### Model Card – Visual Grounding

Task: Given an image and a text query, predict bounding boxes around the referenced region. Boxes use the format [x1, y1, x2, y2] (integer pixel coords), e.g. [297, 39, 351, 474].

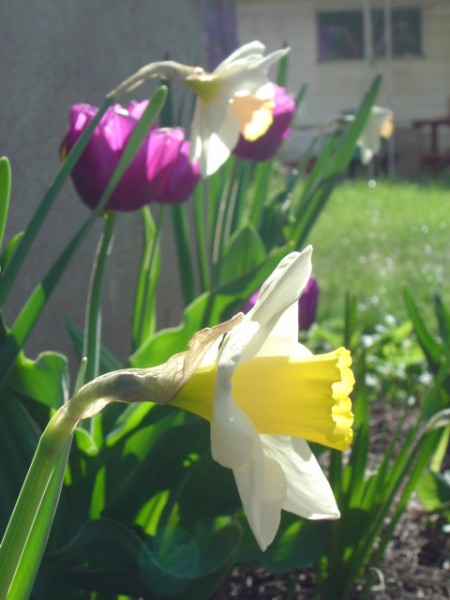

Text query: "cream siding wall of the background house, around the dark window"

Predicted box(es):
[237, 0, 450, 172]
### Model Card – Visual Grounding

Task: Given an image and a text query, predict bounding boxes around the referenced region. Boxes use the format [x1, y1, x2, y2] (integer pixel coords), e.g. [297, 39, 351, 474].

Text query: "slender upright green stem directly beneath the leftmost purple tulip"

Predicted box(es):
[83, 212, 116, 381]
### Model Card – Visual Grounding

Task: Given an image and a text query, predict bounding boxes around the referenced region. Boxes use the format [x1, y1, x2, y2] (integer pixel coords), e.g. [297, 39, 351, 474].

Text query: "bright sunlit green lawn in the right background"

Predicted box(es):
[309, 180, 450, 325]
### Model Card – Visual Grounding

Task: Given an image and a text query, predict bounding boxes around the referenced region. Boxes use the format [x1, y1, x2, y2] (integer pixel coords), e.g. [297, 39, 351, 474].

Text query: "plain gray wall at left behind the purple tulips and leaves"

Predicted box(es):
[0, 0, 202, 370]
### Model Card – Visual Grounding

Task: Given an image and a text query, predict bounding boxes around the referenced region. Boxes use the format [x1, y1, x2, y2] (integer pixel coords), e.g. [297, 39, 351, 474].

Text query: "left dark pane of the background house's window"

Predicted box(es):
[317, 11, 363, 61]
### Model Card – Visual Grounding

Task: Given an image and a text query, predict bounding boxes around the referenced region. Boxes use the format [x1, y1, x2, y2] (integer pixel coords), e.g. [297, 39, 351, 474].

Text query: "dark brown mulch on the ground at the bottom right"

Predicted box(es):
[212, 502, 450, 600]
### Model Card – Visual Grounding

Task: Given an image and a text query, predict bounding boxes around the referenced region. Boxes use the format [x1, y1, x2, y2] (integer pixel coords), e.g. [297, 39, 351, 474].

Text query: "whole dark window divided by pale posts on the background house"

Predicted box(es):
[317, 8, 422, 62]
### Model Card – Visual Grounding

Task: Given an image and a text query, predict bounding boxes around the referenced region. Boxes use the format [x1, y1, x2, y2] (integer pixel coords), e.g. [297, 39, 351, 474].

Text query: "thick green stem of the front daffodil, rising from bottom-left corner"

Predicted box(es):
[0, 405, 78, 600]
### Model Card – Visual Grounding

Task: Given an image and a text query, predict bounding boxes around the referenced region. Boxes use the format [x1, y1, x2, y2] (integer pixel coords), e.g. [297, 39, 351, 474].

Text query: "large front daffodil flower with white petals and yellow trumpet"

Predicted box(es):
[171, 247, 354, 550]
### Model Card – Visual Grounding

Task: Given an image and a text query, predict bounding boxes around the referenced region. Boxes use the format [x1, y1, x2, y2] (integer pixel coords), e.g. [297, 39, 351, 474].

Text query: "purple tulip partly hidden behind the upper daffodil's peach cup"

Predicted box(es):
[233, 83, 295, 162]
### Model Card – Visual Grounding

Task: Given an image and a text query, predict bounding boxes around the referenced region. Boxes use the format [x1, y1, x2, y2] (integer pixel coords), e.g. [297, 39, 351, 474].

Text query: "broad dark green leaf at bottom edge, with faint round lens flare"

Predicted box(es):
[48, 519, 241, 600]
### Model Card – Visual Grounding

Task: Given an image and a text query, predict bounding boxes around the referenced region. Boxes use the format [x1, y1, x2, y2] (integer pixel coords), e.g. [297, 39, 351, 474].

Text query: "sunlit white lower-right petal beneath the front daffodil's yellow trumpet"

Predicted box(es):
[260, 435, 340, 519]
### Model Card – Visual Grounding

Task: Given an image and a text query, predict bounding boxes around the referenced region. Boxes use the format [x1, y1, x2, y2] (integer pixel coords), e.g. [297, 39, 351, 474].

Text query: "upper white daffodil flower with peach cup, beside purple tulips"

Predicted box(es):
[184, 41, 289, 177]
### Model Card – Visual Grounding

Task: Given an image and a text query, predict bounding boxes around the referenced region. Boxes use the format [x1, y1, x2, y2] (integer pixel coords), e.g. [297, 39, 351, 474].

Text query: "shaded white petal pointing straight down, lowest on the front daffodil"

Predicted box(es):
[233, 440, 287, 550]
